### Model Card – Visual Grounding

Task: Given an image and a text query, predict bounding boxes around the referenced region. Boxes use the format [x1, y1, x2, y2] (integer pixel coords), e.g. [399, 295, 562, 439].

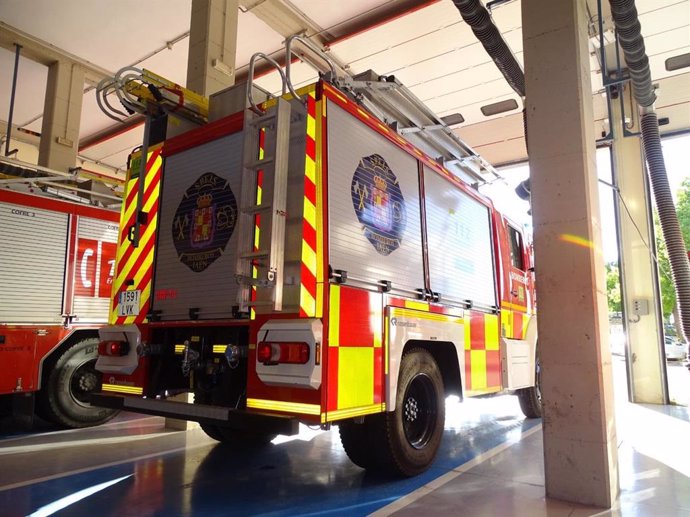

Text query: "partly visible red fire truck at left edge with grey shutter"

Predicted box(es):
[0, 188, 118, 427]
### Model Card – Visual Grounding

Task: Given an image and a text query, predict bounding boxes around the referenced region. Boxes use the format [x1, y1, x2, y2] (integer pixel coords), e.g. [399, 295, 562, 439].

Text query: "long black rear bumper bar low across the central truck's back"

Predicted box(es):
[91, 393, 299, 435]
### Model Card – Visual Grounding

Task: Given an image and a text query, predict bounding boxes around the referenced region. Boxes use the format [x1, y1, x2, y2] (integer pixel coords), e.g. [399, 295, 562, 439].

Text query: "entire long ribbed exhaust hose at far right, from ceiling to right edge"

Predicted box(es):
[609, 0, 690, 340]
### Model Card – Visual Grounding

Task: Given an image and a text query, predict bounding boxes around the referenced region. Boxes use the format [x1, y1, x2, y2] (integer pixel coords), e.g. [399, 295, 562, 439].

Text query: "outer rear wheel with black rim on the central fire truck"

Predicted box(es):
[372, 348, 446, 477]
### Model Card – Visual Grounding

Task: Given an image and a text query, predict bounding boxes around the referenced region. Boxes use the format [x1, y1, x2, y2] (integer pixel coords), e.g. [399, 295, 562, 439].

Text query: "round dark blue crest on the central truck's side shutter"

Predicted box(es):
[351, 154, 407, 256]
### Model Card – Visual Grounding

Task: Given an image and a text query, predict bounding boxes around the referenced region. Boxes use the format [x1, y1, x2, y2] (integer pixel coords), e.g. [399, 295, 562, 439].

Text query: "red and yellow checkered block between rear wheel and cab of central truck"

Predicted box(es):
[465, 311, 502, 396]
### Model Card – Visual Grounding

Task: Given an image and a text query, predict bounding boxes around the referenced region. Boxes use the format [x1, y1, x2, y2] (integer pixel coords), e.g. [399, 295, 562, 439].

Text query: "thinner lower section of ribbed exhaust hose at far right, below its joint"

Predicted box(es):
[641, 113, 690, 340]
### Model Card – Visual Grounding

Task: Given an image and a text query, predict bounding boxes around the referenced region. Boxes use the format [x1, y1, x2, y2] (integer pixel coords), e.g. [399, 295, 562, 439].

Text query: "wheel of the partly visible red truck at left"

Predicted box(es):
[37, 337, 118, 428]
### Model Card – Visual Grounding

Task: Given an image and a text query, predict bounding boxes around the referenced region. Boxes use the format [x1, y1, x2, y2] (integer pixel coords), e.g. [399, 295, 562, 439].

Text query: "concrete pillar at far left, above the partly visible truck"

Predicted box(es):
[38, 61, 84, 172]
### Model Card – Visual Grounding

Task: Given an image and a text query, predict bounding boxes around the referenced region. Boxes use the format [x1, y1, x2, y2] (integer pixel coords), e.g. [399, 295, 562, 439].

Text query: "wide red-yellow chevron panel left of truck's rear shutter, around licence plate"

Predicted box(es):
[109, 144, 163, 325]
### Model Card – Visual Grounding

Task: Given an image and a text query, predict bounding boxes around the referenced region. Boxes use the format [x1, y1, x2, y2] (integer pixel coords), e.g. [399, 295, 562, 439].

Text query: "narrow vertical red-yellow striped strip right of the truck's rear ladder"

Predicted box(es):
[299, 89, 320, 318]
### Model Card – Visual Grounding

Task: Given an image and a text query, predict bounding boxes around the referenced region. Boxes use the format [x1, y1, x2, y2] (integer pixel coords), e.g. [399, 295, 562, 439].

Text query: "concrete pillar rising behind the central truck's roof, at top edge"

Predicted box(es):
[187, 0, 239, 96]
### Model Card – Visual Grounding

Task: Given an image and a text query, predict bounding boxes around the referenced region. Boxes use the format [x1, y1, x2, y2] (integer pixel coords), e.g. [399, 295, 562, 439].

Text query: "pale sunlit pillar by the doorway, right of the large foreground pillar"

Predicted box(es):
[611, 84, 668, 404]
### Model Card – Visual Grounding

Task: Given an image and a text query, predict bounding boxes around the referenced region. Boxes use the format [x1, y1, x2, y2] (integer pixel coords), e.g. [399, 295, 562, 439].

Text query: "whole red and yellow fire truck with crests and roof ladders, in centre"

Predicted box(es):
[93, 48, 541, 475]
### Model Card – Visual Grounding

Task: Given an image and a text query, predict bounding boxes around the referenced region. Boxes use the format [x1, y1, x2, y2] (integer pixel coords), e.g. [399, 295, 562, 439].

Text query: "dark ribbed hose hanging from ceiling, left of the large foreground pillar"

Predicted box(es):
[453, 0, 525, 97]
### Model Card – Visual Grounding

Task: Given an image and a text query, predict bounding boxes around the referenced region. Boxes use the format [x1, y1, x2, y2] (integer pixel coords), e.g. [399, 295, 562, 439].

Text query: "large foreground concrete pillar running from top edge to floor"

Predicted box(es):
[522, 0, 618, 508]
